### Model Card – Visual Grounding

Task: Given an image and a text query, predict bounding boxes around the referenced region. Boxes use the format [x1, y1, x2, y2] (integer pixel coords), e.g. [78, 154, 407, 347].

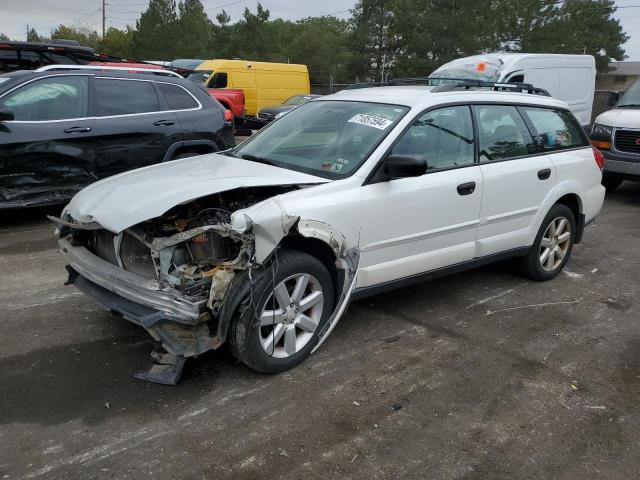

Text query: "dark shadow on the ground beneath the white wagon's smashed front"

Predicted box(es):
[0, 320, 250, 426]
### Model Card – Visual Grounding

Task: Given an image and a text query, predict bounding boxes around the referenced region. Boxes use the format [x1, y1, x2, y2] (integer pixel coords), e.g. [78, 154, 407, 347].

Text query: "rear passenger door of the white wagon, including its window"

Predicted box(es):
[474, 105, 557, 257]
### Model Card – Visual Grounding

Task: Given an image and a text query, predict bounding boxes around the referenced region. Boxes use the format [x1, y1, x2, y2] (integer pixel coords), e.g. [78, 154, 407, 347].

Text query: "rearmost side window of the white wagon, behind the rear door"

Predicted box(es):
[521, 107, 587, 152]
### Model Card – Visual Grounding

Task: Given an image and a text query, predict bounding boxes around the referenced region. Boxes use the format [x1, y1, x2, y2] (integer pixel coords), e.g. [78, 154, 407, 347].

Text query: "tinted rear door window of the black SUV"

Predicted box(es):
[96, 78, 160, 117]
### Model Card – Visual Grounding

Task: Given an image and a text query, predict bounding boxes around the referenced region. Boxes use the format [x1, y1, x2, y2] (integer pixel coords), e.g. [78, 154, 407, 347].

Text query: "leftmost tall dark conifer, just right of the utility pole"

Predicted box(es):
[133, 0, 181, 60]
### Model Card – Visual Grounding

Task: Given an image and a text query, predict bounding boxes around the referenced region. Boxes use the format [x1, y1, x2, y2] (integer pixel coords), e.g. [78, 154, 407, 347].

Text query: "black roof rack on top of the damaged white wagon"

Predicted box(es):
[346, 77, 551, 97]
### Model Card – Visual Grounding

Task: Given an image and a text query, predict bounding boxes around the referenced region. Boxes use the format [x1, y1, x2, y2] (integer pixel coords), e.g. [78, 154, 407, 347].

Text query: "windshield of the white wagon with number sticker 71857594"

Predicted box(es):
[229, 100, 409, 179]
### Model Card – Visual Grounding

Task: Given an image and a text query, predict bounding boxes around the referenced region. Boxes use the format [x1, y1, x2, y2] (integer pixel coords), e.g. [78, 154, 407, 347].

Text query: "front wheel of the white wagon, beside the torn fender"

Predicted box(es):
[230, 250, 334, 373]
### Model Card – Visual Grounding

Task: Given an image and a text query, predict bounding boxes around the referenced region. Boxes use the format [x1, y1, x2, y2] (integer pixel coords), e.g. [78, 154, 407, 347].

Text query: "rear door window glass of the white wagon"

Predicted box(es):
[475, 105, 538, 162]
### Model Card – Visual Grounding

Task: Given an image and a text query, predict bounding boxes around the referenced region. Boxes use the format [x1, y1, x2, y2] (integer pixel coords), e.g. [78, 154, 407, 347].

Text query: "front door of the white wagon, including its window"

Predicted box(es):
[357, 105, 483, 287]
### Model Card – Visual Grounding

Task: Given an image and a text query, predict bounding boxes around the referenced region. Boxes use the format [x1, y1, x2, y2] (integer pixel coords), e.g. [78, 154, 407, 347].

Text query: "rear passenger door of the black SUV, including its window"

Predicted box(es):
[94, 77, 182, 178]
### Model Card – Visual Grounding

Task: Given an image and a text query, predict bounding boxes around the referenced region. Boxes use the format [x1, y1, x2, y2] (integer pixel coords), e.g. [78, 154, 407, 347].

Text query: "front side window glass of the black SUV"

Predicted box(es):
[0, 75, 89, 121]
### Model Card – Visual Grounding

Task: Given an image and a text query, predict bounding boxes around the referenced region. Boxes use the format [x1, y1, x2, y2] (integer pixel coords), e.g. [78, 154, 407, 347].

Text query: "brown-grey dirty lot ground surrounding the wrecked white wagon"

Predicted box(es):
[0, 182, 640, 480]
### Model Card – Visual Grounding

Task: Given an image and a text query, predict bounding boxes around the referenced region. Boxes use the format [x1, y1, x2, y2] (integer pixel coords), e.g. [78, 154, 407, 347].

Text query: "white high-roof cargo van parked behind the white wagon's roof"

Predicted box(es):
[430, 53, 596, 126]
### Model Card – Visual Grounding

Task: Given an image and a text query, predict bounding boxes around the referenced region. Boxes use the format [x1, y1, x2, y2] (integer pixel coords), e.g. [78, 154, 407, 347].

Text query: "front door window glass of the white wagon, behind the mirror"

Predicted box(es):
[392, 106, 474, 171]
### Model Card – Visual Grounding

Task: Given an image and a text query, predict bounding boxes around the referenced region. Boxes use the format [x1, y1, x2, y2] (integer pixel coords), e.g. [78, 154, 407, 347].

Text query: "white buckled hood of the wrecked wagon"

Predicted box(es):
[68, 153, 330, 233]
